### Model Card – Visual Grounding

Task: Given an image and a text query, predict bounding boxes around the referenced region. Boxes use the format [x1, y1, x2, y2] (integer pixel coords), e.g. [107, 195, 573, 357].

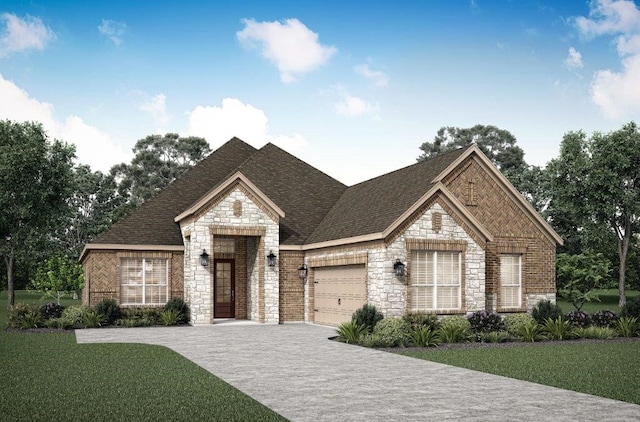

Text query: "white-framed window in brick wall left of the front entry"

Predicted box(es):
[120, 258, 169, 305]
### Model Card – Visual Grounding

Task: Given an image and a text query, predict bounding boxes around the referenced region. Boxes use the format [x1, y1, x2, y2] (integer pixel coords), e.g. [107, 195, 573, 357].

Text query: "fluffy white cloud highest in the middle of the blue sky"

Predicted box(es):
[236, 19, 338, 83]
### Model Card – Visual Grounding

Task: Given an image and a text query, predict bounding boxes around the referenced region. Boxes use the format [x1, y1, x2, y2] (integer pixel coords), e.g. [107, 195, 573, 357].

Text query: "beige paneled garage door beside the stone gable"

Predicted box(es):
[314, 265, 367, 326]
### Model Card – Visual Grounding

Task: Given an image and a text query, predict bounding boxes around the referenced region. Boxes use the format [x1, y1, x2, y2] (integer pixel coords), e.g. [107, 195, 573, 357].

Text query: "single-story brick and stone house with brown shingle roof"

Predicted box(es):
[81, 138, 562, 325]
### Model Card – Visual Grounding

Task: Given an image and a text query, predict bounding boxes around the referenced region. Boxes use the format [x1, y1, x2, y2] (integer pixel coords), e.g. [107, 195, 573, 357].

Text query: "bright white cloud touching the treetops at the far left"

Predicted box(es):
[0, 75, 132, 172]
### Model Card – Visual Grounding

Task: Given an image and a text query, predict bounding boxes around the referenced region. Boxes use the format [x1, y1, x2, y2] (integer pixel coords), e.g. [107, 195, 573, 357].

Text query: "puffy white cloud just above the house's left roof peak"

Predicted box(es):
[188, 98, 308, 153]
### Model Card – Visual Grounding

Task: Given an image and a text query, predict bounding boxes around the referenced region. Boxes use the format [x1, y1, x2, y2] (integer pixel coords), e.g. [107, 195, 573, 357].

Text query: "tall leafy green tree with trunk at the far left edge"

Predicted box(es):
[0, 120, 75, 307]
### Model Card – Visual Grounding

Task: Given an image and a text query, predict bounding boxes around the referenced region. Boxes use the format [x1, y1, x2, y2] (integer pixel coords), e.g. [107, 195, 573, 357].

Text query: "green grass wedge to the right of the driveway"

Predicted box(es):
[401, 341, 640, 404]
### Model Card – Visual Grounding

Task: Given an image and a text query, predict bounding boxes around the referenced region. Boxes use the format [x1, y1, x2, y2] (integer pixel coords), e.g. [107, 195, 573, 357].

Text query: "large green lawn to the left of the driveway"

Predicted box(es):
[0, 291, 285, 421]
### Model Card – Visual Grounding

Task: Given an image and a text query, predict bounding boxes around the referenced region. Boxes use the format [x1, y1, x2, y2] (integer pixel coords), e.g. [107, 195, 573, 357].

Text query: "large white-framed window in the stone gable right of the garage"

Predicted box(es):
[411, 251, 462, 311]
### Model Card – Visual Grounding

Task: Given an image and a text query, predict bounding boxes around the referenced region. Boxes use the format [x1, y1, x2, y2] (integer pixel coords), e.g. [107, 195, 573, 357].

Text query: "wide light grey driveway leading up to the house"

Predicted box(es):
[76, 323, 640, 422]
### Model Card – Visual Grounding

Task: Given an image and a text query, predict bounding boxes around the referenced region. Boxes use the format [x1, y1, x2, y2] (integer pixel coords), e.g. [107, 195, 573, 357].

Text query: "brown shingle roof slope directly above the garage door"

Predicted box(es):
[306, 148, 467, 244]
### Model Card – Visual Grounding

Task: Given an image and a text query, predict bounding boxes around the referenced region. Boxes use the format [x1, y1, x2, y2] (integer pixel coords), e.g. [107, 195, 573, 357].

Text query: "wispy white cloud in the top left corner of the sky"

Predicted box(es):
[0, 13, 56, 58]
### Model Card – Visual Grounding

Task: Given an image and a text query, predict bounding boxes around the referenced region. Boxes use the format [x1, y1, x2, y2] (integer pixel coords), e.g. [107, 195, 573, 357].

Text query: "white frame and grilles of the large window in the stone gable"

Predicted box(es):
[411, 250, 462, 311]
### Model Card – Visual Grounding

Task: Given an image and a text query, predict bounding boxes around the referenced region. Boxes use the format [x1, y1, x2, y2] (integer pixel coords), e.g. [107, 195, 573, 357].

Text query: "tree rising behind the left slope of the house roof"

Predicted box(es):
[110, 133, 211, 208]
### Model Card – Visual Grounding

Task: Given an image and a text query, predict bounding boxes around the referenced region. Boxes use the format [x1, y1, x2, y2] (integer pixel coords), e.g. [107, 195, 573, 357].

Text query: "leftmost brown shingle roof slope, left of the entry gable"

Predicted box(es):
[92, 138, 256, 246]
